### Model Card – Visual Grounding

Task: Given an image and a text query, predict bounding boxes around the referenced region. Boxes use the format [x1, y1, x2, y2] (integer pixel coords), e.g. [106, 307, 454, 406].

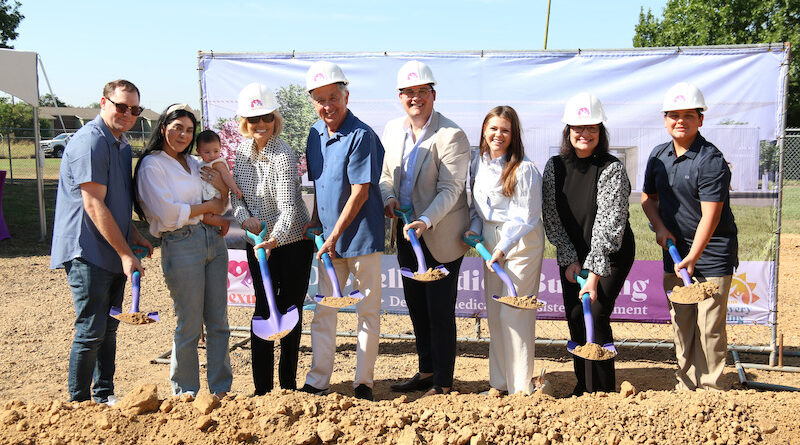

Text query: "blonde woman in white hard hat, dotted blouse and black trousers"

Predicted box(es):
[231, 83, 314, 395]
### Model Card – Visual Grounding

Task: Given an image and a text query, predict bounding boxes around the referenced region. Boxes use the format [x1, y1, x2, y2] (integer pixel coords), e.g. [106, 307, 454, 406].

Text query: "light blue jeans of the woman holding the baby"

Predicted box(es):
[161, 223, 233, 395]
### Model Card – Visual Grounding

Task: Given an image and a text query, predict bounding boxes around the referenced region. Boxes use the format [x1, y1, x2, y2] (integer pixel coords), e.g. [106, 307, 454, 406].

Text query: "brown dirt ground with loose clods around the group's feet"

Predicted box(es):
[0, 235, 800, 445]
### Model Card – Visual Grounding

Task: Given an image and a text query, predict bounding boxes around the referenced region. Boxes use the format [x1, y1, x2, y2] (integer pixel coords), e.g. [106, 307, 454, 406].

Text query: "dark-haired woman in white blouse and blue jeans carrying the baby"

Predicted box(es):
[134, 104, 233, 397]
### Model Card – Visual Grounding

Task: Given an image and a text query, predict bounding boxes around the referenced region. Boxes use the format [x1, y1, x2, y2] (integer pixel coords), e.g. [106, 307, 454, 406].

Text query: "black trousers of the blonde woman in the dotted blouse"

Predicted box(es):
[247, 240, 314, 395]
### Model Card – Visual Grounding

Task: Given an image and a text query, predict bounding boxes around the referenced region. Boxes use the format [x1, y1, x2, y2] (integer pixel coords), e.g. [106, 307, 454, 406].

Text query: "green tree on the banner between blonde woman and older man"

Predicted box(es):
[275, 84, 318, 155]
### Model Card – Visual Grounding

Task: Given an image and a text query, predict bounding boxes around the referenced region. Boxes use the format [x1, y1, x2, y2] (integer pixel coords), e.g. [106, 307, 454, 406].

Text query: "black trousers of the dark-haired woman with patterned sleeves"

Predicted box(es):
[560, 250, 633, 394]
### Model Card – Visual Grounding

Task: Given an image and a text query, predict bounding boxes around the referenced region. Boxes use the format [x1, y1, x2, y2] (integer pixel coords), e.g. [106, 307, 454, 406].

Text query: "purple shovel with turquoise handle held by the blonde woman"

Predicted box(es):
[245, 222, 300, 341]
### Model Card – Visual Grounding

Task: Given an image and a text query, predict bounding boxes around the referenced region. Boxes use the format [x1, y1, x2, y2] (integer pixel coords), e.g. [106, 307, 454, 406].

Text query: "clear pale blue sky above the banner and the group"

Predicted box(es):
[11, 0, 666, 111]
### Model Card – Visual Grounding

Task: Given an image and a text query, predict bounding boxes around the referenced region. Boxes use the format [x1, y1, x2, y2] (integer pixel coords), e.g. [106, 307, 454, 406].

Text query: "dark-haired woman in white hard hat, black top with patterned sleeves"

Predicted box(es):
[542, 93, 636, 395]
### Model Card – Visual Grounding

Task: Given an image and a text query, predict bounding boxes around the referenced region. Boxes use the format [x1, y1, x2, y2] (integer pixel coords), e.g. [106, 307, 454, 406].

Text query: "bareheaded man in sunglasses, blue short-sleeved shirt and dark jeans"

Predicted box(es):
[50, 80, 153, 404]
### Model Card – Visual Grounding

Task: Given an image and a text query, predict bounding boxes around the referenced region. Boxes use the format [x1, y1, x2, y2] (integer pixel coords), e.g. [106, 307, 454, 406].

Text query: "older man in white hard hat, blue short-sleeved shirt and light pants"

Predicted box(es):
[301, 62, 384, 400]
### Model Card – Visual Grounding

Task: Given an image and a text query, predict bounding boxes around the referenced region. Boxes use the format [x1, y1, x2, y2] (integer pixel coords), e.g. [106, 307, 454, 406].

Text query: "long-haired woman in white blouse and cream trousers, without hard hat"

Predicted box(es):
[466, 106, 544, 394]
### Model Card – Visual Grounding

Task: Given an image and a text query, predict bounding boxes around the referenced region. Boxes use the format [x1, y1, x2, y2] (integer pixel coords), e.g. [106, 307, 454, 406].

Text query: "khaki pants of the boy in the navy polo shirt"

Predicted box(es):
[664, 273, 732, 390]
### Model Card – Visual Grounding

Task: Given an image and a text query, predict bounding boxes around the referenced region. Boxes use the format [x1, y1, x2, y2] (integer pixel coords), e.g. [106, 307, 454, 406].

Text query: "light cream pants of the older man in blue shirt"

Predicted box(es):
[306, 252, 383, 389]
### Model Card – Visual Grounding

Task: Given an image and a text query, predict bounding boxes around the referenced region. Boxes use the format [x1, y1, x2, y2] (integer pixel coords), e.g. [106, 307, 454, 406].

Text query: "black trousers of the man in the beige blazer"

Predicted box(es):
[397, 224, 464, 388]
